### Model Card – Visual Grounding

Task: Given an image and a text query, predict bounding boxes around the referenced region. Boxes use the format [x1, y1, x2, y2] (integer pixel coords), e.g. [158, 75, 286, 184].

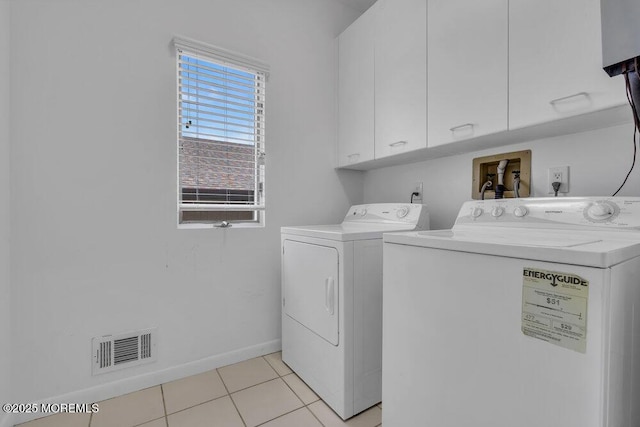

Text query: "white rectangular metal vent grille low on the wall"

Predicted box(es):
[92, 328, 157, 375]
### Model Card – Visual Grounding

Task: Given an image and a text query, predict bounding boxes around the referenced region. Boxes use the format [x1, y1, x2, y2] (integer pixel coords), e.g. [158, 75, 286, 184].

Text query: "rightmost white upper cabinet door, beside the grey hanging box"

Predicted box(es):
[509, 0, 626, 129]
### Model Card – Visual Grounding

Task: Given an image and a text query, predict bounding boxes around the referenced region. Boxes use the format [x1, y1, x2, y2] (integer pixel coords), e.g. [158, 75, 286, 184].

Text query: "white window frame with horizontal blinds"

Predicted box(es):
[173, 37, 269, 228]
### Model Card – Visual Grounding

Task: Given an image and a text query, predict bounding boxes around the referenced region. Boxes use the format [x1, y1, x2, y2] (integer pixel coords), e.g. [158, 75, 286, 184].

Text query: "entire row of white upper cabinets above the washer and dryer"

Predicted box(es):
[338, 0, 640, 169]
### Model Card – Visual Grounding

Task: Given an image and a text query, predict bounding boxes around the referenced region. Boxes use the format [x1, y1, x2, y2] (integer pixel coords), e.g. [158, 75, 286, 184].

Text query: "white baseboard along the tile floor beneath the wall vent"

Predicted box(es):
[13, 339, 282, 427]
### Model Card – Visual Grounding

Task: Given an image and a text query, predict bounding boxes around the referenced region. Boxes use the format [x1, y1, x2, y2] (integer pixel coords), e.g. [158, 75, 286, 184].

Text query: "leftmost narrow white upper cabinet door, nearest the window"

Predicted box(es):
[338, 5, 375, 166]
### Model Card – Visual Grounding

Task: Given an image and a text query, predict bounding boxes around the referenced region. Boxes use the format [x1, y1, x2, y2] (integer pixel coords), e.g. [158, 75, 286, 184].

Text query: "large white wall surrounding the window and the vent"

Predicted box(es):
[10, 0, 363, 402]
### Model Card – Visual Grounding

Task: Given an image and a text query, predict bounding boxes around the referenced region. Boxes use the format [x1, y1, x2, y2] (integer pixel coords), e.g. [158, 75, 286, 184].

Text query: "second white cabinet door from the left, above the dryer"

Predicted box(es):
[375, 0, 427, 159]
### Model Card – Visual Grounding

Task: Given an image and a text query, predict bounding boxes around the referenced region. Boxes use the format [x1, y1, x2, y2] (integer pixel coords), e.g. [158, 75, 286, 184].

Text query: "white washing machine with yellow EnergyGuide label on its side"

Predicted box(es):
[382, 197, 640, 427]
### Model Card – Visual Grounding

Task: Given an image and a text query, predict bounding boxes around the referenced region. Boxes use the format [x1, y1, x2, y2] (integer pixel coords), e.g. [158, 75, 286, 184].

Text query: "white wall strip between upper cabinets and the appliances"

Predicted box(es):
[364, 123, 640, 229]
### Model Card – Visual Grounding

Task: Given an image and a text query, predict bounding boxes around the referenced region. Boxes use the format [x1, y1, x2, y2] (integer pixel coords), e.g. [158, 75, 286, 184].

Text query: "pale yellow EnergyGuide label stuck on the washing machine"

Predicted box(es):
[522, 267, 589, 353]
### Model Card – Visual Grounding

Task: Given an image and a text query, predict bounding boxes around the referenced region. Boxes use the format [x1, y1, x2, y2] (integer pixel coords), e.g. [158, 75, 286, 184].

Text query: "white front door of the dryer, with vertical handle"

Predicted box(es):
[282, 240, 339, 345]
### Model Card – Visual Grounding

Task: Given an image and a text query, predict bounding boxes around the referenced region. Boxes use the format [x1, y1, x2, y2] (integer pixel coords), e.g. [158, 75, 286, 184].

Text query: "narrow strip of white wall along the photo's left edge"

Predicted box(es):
[0, 0, 11, 426]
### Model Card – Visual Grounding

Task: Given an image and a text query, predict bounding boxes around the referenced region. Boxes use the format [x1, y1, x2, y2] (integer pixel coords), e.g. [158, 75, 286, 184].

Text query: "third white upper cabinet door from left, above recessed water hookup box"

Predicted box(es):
[427, 0, 508, 147]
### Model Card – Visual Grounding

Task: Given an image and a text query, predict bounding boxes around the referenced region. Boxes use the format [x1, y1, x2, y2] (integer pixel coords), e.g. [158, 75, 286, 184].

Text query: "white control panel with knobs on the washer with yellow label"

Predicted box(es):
[456, 197, 640, 230]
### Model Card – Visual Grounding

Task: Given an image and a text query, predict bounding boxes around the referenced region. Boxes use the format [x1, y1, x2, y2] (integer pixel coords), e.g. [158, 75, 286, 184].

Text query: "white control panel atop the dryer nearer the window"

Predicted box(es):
[343, 203, 429, 229]
